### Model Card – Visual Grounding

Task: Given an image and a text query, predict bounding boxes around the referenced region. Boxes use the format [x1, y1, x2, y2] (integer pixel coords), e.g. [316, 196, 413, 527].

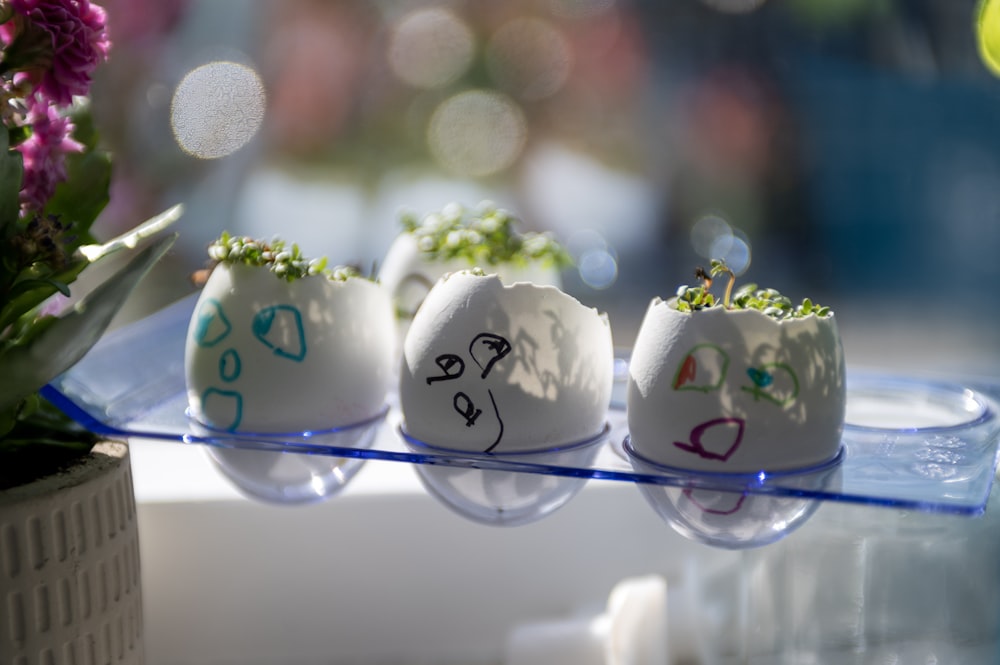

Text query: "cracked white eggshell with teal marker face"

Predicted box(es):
[184, 264, 395, 432]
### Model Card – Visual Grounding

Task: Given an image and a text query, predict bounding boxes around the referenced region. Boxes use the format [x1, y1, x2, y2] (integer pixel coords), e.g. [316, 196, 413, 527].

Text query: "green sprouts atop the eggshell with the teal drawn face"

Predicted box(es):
[208, 231, 361, 282]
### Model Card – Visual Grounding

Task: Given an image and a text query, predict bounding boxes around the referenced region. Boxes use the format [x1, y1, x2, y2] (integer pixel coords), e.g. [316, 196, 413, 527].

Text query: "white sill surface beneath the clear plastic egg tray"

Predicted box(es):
[133, 441, 737, 665]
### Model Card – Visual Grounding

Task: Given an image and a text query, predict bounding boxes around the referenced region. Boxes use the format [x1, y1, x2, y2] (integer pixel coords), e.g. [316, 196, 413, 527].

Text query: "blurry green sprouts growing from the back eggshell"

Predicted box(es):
[401, 201, 572, 268]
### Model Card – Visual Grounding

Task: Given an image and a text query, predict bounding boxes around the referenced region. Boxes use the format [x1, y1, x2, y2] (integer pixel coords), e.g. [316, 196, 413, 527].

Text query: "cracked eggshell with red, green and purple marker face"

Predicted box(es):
[626, 298, 846, 473]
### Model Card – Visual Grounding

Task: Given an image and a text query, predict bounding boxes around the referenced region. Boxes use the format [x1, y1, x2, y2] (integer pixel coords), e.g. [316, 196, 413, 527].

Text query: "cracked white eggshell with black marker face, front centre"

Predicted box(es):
[399, 272, 614, 453]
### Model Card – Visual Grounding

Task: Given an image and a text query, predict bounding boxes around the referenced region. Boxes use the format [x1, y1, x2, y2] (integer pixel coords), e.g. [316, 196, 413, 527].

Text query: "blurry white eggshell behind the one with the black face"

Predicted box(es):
[379, 233, 562, 342]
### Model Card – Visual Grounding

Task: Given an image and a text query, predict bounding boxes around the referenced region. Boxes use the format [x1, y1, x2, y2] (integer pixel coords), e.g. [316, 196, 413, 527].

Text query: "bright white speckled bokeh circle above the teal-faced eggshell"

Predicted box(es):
[170, 61, 267, 159]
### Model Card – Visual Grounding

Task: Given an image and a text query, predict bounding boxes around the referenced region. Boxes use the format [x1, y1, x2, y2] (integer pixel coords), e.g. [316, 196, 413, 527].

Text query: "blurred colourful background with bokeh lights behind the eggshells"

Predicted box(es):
[94, 0, 1000, 377]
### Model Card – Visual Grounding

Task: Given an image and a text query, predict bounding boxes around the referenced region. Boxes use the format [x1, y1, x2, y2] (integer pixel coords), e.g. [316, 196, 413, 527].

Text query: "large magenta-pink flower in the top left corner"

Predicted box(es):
[2, 0, 111, 106]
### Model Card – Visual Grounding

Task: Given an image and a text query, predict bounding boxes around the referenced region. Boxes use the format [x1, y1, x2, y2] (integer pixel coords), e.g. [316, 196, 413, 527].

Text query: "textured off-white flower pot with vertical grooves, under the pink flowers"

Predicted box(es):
[0, 442, 144, 665]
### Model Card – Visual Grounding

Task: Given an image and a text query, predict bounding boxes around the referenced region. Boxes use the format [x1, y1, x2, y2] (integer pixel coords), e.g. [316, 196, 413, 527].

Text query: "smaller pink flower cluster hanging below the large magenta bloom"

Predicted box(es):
[17, 95, 83, 210]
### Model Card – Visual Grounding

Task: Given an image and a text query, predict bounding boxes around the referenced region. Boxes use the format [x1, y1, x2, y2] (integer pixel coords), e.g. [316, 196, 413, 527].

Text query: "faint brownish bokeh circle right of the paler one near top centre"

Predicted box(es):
[486, 18, 572, 100]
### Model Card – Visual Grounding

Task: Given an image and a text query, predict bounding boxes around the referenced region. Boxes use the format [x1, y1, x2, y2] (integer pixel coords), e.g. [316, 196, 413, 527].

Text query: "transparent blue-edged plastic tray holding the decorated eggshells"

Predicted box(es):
[44, 296, 1000, 515]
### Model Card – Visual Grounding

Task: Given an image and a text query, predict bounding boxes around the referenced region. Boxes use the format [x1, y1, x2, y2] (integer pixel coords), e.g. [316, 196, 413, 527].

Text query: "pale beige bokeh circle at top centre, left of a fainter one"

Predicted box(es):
[388, 7, 475, 88]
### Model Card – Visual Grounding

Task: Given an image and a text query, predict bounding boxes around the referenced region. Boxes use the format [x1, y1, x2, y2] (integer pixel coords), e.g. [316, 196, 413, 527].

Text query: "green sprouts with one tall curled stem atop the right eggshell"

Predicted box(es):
[672, 259, 830, 319]
